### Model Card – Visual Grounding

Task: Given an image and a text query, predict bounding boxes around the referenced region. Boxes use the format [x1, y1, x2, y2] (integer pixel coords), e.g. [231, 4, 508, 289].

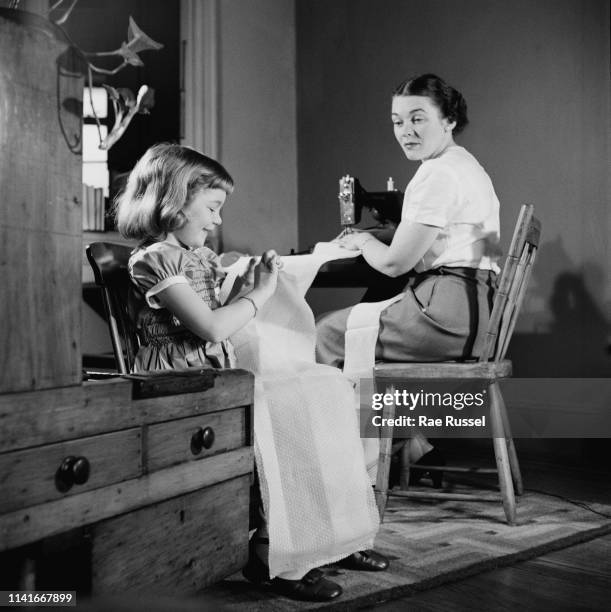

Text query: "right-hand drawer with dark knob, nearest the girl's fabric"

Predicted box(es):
[145, 406, 250, 472]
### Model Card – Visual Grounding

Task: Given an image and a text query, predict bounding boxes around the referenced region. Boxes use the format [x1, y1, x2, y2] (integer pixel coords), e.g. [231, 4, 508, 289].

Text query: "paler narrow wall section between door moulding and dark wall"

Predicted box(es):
[219, 0, 297, 253]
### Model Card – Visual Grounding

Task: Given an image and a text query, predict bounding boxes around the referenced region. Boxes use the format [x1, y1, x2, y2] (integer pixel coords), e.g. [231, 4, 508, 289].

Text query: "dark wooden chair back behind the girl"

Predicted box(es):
[85, 242, 140, 374]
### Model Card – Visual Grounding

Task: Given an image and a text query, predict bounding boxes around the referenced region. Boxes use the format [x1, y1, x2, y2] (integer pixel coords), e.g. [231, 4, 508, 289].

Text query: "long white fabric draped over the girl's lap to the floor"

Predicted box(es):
[221, 245, 379, 576]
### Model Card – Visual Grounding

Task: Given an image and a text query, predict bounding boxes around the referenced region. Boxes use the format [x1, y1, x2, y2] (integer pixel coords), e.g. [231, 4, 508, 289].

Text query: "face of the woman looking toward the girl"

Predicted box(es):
[392, 96, 456, 161]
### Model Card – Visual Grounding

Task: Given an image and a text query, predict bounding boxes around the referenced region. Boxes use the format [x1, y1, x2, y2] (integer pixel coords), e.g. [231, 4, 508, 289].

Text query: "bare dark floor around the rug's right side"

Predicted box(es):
[371, 441, 611, 612]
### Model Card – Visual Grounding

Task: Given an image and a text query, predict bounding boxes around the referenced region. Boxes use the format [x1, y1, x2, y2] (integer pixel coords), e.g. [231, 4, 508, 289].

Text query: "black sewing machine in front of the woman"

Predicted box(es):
[338, 174, 403, 234]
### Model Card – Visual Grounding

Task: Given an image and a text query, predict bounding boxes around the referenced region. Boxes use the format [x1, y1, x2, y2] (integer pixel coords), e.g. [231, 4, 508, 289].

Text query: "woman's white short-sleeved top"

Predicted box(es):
[401, 145, 500, 274]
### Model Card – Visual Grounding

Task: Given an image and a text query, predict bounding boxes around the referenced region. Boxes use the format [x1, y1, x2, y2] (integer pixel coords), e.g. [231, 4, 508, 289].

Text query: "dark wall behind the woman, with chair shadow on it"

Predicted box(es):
[296, 0, 611, 376]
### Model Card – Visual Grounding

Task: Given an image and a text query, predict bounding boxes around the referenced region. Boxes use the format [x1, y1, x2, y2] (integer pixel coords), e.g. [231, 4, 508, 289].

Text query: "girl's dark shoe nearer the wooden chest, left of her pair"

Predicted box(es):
[242, 537, 343, 601]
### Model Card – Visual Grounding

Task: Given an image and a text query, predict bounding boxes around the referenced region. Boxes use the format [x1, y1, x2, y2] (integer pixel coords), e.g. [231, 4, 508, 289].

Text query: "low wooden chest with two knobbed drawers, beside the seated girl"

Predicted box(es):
[0, 370, 253, 594]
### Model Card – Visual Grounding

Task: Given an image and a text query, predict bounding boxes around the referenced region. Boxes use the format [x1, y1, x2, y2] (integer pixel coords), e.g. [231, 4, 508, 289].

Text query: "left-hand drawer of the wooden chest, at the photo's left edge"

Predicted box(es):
[0, 428, 142, 513]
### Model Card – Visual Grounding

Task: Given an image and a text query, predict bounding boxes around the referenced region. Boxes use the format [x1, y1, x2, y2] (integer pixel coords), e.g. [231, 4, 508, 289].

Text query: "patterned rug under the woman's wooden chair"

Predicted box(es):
[204, 485, 611, 612]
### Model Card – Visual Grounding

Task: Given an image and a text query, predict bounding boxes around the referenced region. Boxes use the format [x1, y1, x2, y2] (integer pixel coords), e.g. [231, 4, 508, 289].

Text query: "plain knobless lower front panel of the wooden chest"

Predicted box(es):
[91, 475, 250, 597]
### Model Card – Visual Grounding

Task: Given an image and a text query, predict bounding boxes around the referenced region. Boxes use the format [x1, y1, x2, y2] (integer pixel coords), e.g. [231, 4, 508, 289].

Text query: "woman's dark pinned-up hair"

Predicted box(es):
[392, 73, 469, 134]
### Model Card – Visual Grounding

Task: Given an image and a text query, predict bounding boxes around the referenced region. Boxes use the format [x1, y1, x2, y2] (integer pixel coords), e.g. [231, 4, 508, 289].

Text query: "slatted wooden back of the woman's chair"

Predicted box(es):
[479, 204, 541, 363]
